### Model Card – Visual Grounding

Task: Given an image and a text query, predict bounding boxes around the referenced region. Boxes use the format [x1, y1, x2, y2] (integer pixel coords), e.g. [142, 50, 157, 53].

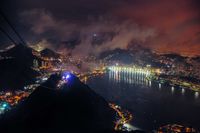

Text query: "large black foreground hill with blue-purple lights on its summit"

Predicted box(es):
[0, 75, 145, 133]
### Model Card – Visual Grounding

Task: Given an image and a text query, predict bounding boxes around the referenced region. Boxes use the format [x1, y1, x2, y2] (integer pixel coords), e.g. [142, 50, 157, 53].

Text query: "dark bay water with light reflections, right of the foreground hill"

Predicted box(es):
[87, 71, 200, 130]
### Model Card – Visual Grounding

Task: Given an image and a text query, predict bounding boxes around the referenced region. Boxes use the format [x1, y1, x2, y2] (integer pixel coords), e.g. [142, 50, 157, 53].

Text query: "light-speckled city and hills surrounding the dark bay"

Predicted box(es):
[0, 45, 200, 133]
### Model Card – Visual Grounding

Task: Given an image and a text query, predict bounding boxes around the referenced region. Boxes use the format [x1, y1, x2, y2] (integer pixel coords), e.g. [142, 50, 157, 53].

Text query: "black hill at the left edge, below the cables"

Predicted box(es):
[0, 44, 39, 90]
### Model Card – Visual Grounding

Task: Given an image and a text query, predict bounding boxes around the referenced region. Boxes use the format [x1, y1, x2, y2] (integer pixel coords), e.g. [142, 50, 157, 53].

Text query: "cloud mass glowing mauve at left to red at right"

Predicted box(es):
[17, 0, 200, 56]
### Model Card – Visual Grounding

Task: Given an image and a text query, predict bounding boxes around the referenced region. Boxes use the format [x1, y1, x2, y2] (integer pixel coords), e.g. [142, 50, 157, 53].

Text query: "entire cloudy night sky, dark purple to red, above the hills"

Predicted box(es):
[0, 0, 200, 56]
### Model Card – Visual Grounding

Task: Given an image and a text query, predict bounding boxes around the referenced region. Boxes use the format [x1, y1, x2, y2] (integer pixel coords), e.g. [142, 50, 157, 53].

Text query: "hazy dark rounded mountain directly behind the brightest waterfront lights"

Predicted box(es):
[99, 45, 161, 66]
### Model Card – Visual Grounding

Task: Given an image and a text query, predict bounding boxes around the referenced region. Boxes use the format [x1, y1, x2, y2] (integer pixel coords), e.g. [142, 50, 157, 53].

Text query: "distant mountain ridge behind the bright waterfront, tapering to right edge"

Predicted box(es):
[98, 45, 200, 68]
